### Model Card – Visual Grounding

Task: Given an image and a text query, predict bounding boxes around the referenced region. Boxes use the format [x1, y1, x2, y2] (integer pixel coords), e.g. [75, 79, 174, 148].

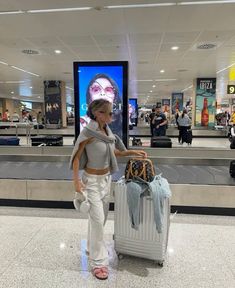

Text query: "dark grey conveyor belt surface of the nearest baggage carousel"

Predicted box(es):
[0, 161, 235, 186]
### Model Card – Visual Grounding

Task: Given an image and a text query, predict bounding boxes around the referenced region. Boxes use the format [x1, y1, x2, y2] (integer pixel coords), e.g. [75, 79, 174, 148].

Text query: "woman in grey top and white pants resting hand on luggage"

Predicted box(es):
[70, 99, 147, 280]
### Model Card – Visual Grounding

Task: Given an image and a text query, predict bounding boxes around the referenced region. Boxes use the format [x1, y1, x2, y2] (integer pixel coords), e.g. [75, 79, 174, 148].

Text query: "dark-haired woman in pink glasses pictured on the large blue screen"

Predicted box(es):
[80, 73, 122, 138]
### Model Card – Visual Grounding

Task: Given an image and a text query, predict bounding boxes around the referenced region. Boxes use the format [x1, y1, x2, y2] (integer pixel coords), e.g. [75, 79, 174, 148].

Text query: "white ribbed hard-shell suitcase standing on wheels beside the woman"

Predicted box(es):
[114, 180, 170, 266]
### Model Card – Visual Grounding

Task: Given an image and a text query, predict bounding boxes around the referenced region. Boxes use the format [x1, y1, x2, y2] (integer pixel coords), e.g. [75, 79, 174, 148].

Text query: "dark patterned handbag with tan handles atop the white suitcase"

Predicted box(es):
[125, 158, 155, 182]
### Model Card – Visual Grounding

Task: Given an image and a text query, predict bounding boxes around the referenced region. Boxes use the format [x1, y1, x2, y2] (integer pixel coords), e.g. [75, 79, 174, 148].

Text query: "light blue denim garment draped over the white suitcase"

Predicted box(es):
[126, 175, 171, 233]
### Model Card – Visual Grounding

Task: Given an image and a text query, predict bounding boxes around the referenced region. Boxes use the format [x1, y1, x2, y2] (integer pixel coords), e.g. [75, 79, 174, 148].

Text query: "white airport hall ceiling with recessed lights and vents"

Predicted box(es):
[0, 0, 235, 104]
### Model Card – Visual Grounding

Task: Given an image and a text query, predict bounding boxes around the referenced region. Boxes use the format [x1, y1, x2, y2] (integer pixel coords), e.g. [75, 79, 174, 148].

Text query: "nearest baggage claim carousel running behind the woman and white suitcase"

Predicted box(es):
[0, 146, 235, 215]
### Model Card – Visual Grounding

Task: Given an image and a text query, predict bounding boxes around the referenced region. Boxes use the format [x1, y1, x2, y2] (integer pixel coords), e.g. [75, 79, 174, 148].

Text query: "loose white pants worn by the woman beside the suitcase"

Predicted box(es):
[82, 172, 111, 268]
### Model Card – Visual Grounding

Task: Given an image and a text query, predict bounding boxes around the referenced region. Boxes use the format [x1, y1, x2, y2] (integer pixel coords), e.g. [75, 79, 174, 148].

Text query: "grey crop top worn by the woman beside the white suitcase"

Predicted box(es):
[85, 138, 115, 169]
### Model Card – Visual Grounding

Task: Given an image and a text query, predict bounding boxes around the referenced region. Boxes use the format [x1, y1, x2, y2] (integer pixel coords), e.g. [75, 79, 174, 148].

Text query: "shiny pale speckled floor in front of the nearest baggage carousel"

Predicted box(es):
[0, 207, 235, 288]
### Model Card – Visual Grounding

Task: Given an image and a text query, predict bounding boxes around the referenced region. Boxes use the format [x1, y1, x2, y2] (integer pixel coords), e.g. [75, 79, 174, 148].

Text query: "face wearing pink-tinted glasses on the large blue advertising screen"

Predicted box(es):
[89, 78, 115, 103]
